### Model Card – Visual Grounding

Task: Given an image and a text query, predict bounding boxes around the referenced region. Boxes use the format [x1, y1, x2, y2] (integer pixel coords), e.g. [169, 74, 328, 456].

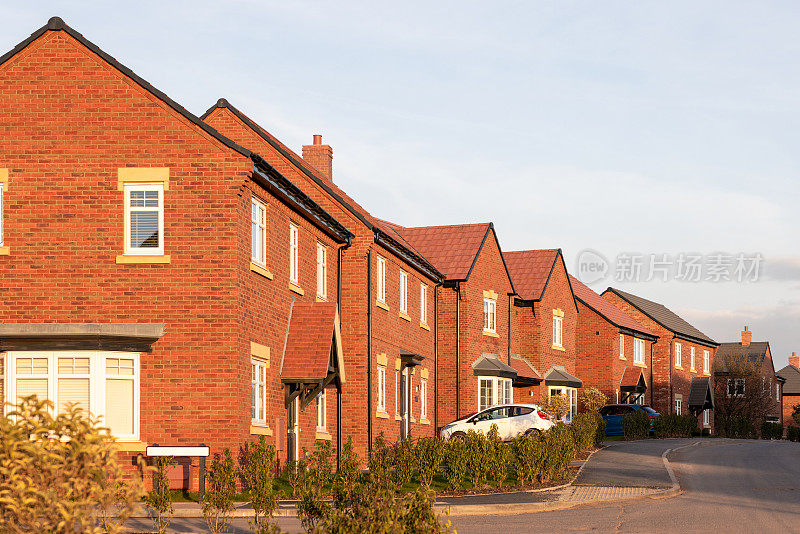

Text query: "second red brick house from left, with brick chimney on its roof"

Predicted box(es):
[198, 99, 442, 457]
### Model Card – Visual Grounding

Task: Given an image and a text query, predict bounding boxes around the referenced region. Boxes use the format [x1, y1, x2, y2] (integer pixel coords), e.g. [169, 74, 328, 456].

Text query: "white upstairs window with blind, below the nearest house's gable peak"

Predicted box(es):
[125, 184, 164, 255]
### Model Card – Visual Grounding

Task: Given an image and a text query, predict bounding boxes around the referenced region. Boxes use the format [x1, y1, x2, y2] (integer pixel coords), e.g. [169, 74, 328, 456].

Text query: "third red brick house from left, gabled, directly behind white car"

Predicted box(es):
[384, 223, 517, 424]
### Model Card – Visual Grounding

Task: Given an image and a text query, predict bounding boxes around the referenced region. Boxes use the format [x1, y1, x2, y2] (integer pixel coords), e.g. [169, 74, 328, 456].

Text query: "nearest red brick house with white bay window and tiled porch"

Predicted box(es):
[0, 18, 353, 486]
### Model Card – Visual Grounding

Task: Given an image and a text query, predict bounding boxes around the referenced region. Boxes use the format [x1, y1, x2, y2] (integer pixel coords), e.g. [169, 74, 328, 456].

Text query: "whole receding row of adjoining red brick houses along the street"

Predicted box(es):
[0, 18, 780, 490]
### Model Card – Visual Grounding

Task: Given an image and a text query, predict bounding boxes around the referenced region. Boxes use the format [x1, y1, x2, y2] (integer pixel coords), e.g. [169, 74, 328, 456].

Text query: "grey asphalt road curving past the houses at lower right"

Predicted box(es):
[129, 439, 800, 534]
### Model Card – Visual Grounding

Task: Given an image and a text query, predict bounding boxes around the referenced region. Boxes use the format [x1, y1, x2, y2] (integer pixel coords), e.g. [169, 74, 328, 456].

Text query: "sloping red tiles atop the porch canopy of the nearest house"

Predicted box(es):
[281, 302, 336, 381]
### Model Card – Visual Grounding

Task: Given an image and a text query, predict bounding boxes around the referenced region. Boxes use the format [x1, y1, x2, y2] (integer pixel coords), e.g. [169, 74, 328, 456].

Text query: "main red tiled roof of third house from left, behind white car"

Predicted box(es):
[383, 221, 491, 280]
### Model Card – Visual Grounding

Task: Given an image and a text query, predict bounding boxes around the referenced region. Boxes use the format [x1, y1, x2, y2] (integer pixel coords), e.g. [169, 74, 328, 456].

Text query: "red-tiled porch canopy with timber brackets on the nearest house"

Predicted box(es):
[280, 302, 345, 410]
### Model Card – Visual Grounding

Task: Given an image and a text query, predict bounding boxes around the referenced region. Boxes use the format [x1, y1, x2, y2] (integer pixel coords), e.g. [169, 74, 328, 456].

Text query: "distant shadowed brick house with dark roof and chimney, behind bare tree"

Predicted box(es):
[714, 326, 785, 428]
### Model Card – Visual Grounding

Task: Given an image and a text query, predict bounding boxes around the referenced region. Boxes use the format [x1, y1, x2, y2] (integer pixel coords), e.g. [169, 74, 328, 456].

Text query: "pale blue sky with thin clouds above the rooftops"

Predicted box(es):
[6, 0, 800, 369]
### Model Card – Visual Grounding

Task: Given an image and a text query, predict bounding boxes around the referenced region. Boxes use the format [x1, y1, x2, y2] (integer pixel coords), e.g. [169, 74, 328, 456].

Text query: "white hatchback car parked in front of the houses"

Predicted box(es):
[440, 404, 555, 441]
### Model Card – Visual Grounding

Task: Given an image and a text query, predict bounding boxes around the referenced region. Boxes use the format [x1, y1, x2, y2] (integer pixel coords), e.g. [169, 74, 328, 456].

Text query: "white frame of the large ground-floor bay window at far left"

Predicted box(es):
[4, 351, 141, 442]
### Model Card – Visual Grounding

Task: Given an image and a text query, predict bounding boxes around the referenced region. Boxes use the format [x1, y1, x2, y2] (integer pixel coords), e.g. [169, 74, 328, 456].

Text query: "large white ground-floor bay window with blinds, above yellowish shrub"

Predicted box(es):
[6, 351, 139, 441]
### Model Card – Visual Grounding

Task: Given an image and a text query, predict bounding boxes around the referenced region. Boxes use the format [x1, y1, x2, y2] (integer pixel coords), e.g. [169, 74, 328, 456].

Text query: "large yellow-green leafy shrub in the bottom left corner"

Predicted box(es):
[0, 396, 150, 533]
